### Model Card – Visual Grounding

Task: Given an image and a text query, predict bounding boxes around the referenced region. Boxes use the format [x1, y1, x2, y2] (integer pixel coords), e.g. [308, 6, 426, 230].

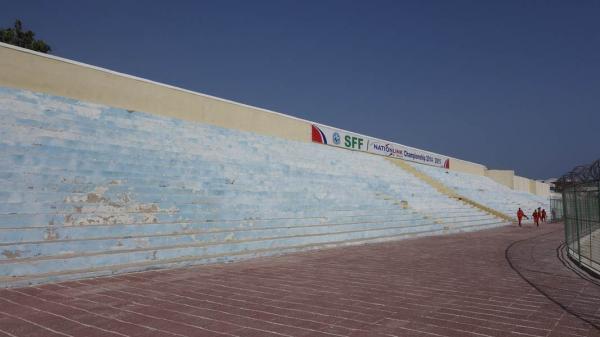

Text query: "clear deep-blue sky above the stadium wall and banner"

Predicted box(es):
[0, 0, 600, 178]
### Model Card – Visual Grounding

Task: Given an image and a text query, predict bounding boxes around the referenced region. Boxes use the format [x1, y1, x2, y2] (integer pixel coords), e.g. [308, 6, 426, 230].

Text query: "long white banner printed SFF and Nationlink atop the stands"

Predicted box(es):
[311, 124, 450, 168]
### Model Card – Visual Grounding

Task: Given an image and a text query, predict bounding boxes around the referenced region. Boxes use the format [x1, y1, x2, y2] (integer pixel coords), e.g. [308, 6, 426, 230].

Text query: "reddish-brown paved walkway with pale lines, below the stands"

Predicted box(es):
[0, 225, 600, 337]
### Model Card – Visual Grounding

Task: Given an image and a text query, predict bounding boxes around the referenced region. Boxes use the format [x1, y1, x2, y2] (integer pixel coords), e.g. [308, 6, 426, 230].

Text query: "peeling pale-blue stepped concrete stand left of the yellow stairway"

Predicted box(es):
[0, 87, 506, 287]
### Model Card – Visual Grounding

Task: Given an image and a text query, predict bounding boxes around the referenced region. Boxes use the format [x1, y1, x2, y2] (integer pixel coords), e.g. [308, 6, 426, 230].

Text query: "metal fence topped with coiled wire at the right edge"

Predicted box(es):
[558, 161, 600, 274]
